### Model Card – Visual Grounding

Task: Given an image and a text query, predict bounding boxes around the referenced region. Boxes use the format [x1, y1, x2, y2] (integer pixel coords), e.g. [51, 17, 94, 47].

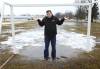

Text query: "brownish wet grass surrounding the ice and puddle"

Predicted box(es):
[0, 21, 100, 69]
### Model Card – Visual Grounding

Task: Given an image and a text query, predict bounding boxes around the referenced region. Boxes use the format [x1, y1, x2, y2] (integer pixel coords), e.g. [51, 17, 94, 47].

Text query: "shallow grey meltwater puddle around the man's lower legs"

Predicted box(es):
[20, 46, 83, 59]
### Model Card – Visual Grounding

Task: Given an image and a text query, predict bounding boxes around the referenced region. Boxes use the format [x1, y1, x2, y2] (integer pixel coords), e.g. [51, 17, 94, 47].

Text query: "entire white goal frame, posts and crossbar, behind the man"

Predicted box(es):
[0, 1, 99, 44]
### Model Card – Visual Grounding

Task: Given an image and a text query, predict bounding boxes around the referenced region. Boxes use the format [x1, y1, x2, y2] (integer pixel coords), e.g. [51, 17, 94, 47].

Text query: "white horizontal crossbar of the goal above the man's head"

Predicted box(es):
[4, 1, 100, 7]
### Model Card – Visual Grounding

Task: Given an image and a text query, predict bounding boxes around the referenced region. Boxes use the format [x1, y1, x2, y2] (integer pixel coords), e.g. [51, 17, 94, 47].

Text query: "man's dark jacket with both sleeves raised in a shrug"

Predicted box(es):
[38, 16, 64, 36]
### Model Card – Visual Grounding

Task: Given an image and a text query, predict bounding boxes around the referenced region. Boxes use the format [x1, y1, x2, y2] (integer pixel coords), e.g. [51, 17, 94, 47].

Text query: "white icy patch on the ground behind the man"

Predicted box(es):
[2, 28, 96, 53]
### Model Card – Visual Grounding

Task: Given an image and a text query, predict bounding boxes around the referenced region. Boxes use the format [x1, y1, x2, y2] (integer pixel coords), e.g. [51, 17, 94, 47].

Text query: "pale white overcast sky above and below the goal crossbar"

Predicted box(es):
[0, 0, 100, 15]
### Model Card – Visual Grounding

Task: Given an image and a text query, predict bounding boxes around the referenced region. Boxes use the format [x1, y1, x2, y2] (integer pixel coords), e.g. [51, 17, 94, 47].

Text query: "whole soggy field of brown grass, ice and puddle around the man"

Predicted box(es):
[0, 21, 100, 69]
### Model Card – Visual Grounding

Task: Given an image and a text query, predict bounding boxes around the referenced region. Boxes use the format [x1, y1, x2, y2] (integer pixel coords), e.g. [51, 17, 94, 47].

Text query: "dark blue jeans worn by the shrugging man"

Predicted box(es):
[44, 35, 56, 59]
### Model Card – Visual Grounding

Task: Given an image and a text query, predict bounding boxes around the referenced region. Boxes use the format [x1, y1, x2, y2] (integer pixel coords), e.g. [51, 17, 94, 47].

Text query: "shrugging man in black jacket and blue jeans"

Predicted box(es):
[37, 10, 65, 60]
